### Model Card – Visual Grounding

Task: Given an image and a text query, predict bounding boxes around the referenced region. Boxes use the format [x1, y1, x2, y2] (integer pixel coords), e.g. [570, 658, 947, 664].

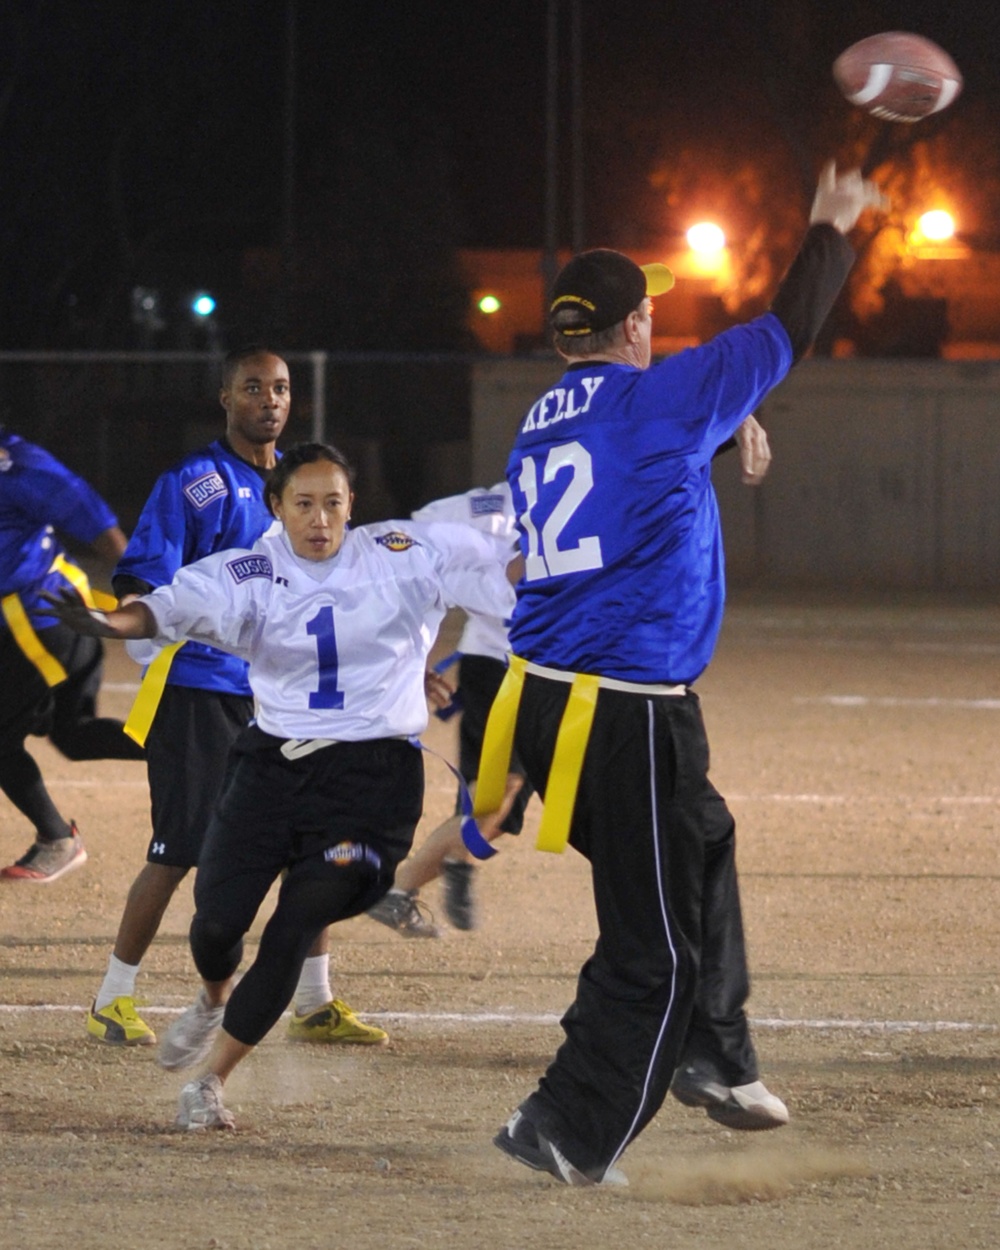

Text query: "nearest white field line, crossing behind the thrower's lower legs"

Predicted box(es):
[0, 1003, 1000, 1034]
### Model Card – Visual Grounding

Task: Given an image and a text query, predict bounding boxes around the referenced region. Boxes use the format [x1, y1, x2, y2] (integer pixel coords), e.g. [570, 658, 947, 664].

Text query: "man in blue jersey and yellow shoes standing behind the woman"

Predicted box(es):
[86, 344, 386, 1045]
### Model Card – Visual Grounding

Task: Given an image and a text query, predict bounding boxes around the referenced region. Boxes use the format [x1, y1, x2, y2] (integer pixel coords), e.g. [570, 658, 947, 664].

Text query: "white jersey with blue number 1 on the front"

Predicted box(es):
[143, 521, 514, 741]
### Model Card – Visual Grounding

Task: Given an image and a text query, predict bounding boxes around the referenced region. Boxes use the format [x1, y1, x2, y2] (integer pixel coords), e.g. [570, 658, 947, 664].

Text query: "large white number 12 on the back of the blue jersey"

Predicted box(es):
[518, 443, 604, 581]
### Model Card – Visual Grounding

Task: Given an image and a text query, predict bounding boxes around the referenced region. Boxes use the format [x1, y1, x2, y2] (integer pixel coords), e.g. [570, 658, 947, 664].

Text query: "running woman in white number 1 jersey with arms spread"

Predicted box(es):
[45, 444, 514, 1129]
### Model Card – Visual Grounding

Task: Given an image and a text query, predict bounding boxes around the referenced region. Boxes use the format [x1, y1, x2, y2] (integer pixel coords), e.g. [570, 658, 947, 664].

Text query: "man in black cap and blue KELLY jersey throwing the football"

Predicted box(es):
[487, 164, 881, 1185]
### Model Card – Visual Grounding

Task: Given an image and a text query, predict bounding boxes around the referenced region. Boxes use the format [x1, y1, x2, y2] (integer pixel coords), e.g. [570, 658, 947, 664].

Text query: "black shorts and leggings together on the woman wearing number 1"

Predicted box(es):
[191, 726, 424, 1046]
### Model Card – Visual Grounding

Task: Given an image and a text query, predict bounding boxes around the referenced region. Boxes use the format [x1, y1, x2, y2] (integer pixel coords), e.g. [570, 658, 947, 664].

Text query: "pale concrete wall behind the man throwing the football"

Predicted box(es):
[471, 358, 1000, 590]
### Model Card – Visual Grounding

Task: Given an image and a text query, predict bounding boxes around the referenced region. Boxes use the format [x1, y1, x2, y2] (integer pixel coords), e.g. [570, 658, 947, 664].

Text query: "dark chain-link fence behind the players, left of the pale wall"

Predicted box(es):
[0, 351, 475, 531]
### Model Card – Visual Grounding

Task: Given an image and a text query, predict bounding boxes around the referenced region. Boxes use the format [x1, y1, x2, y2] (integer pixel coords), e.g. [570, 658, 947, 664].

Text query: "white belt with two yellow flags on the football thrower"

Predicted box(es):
[463, 655, 688, 859]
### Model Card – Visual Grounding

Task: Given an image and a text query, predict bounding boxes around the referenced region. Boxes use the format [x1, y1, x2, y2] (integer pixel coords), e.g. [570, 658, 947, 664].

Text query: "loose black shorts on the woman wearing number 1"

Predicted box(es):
[195, 726, 424, 933]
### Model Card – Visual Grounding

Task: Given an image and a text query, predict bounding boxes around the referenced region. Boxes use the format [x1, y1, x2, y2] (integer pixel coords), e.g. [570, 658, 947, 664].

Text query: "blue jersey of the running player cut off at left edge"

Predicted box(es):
[0, 429, 118, 629]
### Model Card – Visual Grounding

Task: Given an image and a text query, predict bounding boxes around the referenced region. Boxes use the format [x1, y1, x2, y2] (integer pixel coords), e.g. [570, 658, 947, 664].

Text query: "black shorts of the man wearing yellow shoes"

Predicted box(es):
[146, 685, 254, 868]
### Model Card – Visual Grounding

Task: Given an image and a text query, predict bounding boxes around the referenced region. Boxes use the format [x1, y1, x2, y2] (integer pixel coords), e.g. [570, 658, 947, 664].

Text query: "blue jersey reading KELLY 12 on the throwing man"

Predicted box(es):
[508, 314, 791, 684]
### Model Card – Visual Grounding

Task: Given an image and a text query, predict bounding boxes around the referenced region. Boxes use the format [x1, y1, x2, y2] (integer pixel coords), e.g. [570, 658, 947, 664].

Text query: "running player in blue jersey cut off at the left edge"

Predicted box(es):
[0, 426, 143, 885]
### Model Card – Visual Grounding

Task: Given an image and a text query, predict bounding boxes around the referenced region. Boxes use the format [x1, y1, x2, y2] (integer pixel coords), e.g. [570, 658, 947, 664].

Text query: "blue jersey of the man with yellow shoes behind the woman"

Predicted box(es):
[115, 441, 274, 698]
